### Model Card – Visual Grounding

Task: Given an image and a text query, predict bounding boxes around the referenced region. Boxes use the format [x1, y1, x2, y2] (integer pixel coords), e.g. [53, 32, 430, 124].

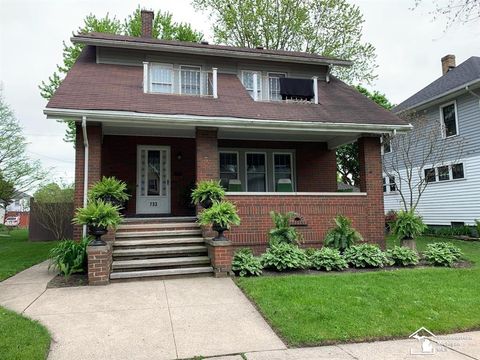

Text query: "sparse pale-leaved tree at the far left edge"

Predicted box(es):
[0, 92, 47, 206]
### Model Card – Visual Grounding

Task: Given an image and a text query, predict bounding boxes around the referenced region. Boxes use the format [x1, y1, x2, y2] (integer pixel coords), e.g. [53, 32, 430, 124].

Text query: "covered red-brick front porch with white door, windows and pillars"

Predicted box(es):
[75, 124, 384, 252]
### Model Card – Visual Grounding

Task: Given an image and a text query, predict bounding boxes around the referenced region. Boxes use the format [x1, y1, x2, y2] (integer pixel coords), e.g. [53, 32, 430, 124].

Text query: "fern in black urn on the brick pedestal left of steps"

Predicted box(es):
[73, 200, 122, 246]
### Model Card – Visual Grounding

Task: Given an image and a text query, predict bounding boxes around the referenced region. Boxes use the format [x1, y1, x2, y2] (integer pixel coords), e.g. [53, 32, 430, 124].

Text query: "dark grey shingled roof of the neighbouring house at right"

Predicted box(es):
[392, 56, 480, 113]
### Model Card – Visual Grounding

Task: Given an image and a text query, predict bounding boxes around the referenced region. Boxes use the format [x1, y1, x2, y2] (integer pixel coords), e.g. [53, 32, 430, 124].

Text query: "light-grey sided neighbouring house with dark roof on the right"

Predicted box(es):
[384, 55, 480, 225]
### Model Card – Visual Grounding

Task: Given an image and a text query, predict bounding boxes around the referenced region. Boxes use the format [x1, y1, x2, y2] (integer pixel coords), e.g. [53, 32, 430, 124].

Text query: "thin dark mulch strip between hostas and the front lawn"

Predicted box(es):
[261, 261, 472, 276]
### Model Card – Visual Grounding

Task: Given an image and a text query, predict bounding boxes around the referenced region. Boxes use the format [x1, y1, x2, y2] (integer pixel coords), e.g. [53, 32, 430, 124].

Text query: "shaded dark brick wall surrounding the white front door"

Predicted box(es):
[102, 135, 195, 215]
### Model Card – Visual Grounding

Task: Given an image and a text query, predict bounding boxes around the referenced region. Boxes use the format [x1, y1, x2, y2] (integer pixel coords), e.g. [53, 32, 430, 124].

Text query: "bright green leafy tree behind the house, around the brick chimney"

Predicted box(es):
[39, 7, 203, 143]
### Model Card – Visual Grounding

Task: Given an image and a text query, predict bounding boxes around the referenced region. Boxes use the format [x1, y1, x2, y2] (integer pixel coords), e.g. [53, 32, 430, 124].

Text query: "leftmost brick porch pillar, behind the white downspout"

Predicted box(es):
[73, 124, 102, 240]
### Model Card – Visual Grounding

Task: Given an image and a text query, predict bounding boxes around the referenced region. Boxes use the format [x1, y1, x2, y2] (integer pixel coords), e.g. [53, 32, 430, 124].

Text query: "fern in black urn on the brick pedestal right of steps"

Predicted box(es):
[198, 201, 240, 241]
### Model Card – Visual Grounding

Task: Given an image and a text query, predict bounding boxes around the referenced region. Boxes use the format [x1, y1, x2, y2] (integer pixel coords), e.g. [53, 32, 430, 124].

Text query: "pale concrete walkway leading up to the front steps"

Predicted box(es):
[0, 263, 285, 360]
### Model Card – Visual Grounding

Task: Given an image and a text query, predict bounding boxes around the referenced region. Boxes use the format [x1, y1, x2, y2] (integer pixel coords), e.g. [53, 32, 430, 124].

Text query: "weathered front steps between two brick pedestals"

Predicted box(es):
[110, 217, 213, 280]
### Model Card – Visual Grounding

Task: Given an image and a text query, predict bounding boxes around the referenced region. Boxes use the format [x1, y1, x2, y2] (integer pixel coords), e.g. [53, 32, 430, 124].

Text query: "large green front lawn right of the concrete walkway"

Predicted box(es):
[237, 237, 480, 346]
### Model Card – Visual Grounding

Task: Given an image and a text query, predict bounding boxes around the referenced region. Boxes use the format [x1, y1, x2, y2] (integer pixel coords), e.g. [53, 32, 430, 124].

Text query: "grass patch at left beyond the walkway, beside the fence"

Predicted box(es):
[0, 230, 57, 281]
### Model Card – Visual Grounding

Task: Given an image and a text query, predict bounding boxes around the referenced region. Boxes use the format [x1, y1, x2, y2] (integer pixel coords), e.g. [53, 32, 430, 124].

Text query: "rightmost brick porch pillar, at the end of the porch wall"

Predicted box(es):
[358, 137, 385, 248]
